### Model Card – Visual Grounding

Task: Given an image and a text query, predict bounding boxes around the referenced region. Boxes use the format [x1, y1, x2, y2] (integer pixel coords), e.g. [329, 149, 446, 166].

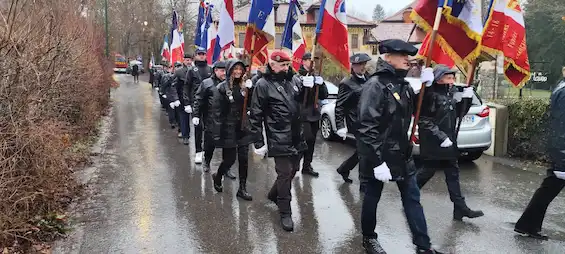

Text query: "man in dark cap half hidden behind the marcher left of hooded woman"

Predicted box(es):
[194, 47, 212, 164]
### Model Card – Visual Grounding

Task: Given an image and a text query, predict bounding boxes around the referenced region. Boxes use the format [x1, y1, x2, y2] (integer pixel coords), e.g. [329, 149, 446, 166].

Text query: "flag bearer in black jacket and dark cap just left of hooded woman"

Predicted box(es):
[192, 61, 225, 172]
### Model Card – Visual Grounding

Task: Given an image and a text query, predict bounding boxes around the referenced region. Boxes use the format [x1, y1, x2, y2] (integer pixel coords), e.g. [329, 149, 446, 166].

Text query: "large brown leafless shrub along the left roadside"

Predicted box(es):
[0, 0, 113, 249]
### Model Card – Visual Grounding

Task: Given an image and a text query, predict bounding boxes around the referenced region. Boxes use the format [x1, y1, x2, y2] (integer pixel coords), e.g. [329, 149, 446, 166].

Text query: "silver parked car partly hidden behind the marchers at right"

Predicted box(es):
[320, 78, 492, 161]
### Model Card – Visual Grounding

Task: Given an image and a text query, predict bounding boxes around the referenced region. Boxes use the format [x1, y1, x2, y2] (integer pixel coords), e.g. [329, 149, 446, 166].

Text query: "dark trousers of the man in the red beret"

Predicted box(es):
[268, 155, 300, 216]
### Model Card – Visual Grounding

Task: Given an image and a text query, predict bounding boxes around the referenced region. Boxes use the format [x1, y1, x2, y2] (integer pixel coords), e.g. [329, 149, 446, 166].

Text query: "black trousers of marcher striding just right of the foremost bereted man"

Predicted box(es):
[417, 160, 467, 208]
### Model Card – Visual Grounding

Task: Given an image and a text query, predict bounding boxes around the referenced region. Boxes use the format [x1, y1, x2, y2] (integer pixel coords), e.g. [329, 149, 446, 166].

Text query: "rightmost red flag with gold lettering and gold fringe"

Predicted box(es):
[482, 0, 531, 87]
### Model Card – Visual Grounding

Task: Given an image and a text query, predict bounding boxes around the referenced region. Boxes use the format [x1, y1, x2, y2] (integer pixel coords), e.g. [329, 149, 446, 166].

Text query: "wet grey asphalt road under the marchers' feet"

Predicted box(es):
[55, 75, 565, 254]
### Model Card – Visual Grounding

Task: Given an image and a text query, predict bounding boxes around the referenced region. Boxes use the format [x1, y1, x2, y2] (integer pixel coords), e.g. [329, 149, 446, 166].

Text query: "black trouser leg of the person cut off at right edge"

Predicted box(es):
[516, 175, 565, 233]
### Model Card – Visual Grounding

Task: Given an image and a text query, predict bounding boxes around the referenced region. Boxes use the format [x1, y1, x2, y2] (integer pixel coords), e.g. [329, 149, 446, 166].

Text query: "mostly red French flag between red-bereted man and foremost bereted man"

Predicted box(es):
[316, 0, 350, 71]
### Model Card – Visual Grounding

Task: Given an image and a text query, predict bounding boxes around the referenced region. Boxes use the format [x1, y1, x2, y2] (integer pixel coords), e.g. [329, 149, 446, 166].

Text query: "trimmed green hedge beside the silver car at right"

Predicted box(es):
[499, 98, 549, 161]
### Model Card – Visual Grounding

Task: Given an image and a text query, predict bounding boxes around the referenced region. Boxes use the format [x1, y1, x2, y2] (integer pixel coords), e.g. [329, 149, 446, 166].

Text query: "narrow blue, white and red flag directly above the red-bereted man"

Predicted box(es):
[281, 0, 306, 70]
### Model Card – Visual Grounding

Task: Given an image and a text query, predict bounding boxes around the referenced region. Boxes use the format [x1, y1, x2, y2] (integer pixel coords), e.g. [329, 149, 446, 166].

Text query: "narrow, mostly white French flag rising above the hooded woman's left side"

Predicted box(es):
[212, 0, 235, 62]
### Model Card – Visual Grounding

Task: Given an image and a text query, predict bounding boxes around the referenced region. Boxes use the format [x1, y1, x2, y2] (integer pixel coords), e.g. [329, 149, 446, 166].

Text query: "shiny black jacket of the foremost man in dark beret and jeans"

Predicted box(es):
[357, 59, 416, 180]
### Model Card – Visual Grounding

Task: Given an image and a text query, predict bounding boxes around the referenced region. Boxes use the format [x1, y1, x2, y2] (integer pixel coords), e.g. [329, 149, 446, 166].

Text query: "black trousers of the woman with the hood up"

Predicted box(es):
[218, 145, 249, 185]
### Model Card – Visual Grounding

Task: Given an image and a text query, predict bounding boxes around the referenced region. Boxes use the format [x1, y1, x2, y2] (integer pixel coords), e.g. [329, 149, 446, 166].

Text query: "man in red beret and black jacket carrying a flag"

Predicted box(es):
[249, 51, 306, 231]
